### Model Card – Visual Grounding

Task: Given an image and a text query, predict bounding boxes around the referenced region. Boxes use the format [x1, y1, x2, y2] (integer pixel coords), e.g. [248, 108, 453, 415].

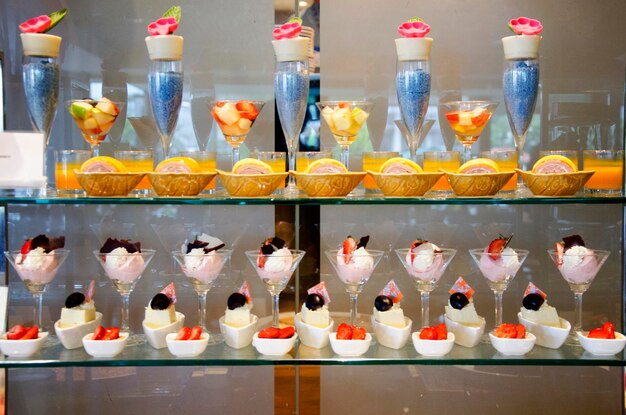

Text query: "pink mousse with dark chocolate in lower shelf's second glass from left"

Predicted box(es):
[100, 238, 144, 283]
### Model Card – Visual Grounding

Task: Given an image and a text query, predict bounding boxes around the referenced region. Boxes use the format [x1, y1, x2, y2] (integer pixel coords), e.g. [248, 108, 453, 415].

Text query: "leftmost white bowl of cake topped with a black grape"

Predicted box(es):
[54, 280, 102, 350]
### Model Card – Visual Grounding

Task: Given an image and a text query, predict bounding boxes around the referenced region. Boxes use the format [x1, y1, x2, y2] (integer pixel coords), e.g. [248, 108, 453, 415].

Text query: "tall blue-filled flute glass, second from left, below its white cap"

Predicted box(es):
[148, 59, 183, 159]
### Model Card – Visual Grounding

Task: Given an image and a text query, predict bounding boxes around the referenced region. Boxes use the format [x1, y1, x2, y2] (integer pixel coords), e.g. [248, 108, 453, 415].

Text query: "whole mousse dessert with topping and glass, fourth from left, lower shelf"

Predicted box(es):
[246, 236, 304, 327]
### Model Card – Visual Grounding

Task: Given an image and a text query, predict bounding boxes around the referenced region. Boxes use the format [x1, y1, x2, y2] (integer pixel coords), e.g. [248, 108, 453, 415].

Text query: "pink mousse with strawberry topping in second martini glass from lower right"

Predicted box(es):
[478, 235, 522, 282]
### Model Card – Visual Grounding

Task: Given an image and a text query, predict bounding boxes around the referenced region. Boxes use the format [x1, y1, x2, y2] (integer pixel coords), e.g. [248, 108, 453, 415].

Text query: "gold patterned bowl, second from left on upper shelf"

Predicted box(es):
[148, 172, 217, 196]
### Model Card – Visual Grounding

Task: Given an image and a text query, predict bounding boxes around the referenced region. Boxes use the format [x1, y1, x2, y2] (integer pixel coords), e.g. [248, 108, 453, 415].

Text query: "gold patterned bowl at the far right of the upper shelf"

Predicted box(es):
[516, 169, 595, 196]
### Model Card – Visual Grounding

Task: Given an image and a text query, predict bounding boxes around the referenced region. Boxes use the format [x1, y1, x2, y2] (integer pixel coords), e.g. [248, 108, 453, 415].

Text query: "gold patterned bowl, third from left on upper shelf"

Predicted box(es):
[217, 170, 288, 197]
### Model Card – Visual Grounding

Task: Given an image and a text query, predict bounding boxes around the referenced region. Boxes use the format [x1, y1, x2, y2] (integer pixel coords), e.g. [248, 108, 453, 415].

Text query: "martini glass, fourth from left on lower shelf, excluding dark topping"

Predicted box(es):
[246, 249, 305, 327]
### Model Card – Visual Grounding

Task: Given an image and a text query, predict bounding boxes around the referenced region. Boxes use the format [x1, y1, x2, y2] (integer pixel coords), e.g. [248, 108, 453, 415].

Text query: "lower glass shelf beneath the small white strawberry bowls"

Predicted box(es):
[0, 341, 626, 368]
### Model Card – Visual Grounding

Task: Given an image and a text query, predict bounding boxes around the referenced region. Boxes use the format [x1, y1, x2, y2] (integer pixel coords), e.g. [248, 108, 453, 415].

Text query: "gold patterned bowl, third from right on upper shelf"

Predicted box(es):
[367, 170, 443, 197]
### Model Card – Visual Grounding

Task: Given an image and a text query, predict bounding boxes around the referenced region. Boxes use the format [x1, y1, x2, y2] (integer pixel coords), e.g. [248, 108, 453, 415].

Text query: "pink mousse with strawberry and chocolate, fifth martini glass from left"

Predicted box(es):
[337, 236, 374, 284]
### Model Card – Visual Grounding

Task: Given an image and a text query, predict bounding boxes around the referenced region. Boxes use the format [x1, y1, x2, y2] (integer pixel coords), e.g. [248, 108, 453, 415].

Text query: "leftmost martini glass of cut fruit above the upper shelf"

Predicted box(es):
[65, 99, 122, 157]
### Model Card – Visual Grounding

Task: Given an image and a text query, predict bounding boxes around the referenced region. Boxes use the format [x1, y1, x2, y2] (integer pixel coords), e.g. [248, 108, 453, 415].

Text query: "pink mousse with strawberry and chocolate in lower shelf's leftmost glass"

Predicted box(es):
[15, 235, 65, 284]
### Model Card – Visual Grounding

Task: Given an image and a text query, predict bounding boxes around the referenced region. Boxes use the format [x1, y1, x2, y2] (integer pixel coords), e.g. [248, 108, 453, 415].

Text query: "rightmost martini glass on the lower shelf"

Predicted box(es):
[548, 249, 610, 334]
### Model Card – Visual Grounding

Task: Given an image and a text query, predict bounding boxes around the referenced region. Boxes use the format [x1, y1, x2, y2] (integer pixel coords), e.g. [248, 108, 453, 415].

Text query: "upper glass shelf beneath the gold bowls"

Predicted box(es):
[0, 194, 626, 206]
